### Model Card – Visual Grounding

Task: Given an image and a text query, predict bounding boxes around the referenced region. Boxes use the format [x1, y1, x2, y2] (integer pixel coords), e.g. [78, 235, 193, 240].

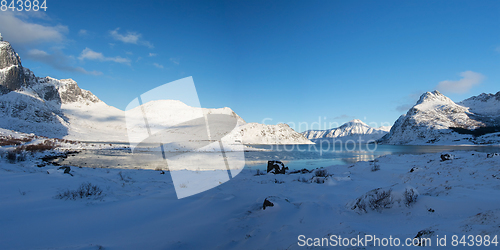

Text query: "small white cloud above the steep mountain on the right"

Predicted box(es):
[436, 71, 486, 94]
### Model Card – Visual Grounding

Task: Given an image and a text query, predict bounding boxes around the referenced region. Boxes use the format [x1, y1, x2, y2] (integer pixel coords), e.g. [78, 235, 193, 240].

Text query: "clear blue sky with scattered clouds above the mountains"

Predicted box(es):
[0, 0, 500, 131]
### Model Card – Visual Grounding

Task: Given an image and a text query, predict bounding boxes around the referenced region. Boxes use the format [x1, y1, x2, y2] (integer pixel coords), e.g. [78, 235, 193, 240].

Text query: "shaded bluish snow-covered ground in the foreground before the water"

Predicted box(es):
[0, 151, 500, 249]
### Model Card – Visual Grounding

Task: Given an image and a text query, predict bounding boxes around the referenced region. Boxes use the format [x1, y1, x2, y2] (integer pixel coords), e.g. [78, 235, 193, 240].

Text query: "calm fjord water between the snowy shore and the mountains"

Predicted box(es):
[59, 143, 500, 170]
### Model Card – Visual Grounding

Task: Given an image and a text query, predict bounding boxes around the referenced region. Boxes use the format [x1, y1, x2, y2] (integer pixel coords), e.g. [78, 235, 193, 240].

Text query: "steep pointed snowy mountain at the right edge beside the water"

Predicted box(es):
[380, 91, 500, 144]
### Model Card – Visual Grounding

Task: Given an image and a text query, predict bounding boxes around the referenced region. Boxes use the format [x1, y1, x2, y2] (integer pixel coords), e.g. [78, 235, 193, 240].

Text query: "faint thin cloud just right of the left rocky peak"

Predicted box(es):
[26, 49, 102, 75]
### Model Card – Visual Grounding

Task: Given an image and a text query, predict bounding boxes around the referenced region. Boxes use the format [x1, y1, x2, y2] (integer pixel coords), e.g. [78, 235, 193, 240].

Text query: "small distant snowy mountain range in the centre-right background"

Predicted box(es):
[302, 119, 390, 142]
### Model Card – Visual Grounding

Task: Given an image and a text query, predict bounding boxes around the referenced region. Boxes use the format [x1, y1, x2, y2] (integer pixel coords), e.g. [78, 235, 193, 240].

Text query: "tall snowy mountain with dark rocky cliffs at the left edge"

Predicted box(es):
[0, 37, 126, 141]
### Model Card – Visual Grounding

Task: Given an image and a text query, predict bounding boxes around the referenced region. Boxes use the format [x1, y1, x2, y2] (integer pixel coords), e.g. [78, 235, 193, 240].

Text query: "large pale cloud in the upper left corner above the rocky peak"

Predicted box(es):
[0, 11, 68, 44]
